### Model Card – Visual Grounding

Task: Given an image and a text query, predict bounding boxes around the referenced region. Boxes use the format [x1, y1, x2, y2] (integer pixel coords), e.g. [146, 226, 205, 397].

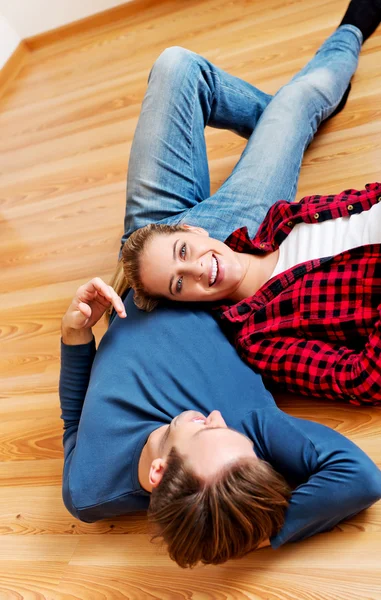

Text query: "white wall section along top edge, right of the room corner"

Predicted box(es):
[0, 0, 131, 39]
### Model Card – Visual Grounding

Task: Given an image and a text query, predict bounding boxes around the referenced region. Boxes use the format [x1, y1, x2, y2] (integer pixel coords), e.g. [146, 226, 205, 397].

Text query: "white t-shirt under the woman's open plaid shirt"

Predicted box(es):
[271, 202, 381, 277]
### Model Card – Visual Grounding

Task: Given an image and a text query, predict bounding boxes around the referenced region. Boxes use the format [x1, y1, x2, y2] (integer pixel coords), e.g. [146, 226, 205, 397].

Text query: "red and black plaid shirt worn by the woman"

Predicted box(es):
[217, 183, 381, 405]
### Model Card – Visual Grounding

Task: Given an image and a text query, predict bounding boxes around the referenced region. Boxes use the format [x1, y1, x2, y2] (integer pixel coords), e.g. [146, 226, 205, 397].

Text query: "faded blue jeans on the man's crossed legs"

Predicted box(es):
[122, 25, 362, 245]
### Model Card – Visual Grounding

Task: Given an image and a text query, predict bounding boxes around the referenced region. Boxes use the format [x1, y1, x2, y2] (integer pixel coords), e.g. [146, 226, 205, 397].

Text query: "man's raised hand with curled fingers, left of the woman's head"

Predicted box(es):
[62, 277, 127, 330]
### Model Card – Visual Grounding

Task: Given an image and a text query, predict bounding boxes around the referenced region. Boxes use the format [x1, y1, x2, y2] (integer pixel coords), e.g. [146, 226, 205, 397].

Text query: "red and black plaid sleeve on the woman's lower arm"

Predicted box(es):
[239, 314, 381, 406]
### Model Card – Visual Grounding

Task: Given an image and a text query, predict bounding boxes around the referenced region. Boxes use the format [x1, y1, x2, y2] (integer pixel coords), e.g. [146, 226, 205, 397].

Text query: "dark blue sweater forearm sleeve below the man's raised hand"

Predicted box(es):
[59, 338, 96, 518]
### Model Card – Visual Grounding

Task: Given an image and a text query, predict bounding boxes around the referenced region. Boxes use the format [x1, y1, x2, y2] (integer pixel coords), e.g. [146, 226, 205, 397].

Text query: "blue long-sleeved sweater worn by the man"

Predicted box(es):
[60, 294, 381, 548]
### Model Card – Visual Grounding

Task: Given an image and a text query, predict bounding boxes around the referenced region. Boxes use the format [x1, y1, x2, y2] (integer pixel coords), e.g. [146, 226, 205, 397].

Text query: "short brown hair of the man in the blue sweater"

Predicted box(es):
[147, 447, 291, 568]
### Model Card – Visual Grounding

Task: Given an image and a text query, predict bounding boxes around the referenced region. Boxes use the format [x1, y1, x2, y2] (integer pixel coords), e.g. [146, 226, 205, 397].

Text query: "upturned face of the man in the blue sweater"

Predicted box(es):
[151, 410, 256, 478]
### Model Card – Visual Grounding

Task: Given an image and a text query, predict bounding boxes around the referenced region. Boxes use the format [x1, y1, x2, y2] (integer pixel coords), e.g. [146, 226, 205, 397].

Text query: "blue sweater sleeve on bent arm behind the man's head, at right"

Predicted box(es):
[271, 415, 381, 548]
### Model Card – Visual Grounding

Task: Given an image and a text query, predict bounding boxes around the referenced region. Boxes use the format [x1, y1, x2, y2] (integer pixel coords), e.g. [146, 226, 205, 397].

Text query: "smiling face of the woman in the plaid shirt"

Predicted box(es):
[140, 226, 247, 302]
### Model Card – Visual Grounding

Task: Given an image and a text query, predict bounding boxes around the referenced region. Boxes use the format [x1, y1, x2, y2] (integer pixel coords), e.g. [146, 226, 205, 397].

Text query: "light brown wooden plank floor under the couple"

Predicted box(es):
[0, 0, 381, 600]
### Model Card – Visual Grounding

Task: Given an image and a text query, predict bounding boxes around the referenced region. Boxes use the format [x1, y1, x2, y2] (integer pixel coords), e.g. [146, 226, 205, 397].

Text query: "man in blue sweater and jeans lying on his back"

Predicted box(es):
[60, 3, 381, 567]
